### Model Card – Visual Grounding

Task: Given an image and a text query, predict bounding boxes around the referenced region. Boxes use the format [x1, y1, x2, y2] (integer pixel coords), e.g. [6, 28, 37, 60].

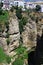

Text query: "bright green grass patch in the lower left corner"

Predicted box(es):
[0, 47, 11, 63]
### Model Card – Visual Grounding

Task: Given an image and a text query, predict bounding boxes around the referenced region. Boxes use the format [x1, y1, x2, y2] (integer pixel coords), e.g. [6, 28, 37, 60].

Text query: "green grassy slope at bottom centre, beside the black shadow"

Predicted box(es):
[12, 45, 28, 65]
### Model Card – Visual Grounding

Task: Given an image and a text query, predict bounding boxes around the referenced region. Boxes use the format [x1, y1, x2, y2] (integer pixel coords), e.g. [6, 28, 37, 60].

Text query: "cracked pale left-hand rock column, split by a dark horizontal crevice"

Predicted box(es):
[0, 15, 20, 55]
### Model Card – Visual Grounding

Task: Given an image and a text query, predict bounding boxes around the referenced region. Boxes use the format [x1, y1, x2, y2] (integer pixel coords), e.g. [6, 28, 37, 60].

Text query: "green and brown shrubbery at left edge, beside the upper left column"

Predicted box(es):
[0, 11, 9, 32]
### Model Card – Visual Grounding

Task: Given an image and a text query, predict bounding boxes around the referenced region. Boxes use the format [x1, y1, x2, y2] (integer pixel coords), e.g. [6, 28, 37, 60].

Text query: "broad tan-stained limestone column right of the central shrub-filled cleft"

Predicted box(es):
[22, 20, 37, 47]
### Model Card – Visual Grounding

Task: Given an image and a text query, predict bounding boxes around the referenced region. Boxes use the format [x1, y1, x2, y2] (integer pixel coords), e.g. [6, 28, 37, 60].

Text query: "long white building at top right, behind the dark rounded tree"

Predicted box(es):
[26, 1, 43, 12]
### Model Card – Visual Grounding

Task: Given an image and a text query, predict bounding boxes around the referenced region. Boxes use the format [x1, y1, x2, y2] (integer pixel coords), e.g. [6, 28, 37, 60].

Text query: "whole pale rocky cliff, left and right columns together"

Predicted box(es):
[0, 10, 43, 65]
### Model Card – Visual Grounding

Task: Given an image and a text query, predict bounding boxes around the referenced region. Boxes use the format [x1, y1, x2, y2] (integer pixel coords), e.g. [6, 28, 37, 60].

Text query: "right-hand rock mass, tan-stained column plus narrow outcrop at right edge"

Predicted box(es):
[22, 19, 43, 48]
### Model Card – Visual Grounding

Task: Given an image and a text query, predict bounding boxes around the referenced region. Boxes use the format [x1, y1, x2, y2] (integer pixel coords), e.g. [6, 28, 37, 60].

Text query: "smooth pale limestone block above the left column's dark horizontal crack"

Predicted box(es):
[9, 18, 19, 34]
